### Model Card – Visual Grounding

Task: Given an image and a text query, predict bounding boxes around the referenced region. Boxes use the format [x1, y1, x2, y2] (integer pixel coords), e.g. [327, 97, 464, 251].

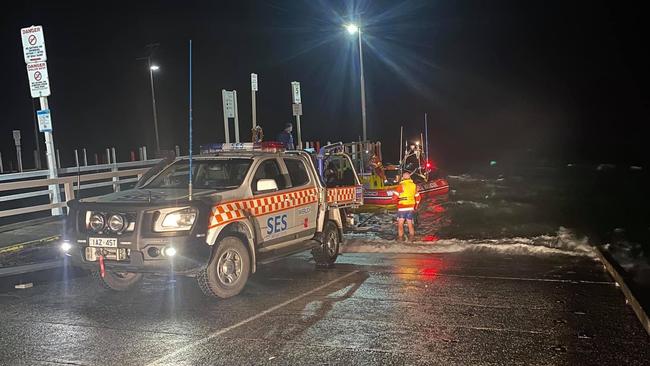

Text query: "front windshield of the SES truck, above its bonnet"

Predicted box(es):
[143, 159, 252, 189]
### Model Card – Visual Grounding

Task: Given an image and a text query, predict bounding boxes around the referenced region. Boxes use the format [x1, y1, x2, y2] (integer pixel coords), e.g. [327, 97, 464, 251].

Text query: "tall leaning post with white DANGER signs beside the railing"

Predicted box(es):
[20, 25, 63, 215]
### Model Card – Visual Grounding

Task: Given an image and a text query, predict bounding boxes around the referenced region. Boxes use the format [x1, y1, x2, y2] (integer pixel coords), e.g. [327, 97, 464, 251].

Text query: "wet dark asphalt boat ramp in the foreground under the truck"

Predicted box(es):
[0, 252, 650, 365]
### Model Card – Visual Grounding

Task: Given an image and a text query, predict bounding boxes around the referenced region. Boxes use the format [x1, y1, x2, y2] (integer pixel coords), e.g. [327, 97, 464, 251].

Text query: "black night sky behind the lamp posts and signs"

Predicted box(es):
[0, 0, 650, 169]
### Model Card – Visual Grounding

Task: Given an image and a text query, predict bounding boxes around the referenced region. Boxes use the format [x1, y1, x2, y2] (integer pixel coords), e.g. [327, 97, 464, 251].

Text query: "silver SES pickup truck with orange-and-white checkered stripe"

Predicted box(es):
[64, 142, 363, 298]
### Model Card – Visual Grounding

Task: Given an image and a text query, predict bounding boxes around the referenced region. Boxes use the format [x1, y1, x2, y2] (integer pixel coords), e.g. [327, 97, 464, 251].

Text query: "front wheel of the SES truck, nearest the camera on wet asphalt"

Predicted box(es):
[196, 236, 251, 299]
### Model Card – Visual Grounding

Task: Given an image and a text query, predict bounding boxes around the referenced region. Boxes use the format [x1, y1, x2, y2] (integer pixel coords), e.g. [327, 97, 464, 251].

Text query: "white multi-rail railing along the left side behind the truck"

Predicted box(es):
[0, 159, 160, 218]
